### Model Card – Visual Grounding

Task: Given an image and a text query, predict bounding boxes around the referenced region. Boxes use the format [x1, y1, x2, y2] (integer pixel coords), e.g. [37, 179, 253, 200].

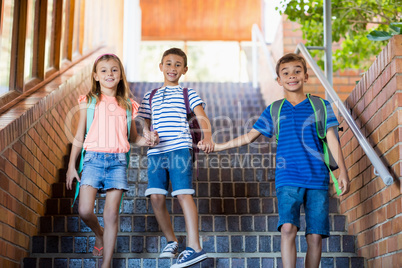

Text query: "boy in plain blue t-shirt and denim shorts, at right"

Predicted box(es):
[203, 53, 349, 267]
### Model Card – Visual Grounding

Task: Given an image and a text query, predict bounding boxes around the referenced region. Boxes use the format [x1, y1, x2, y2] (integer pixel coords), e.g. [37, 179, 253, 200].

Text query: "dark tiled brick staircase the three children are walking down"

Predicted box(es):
[23, 83, 364, 268]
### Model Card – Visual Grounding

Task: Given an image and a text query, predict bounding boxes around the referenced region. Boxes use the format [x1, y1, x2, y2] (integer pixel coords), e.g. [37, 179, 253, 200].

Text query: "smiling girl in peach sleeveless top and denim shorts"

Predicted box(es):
[66, 54, 159, 267]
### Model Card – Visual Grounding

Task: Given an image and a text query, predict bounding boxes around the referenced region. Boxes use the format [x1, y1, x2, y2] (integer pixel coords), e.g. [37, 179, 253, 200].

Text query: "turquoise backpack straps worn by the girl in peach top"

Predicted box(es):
[71, 98, 132, 211]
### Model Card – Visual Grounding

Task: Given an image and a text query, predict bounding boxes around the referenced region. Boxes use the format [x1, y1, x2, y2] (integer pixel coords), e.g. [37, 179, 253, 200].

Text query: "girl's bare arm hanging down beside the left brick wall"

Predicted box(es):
[66, 102, 87, 190]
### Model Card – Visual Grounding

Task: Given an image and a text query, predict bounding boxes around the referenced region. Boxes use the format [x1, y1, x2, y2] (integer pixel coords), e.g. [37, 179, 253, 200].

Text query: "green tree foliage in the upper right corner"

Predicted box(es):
[277, 0, 402, 71]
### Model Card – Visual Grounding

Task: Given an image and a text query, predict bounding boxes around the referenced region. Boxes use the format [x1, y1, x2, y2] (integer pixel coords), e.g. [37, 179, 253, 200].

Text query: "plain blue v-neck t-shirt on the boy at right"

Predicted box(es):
[253, 98, 339, 190]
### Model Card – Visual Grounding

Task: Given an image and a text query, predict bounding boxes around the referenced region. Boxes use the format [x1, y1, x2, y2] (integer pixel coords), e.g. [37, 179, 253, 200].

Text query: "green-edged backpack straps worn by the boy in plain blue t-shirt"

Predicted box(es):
[270, 94, 341, 195]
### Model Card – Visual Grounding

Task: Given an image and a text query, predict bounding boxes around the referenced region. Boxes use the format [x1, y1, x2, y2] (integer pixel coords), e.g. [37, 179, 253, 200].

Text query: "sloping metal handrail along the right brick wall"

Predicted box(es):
[295, 43, 394, 185]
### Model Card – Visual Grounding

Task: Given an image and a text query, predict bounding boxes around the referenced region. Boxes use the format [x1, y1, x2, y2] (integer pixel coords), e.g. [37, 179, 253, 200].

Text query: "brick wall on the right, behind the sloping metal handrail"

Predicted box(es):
[341, 35, 402, 267]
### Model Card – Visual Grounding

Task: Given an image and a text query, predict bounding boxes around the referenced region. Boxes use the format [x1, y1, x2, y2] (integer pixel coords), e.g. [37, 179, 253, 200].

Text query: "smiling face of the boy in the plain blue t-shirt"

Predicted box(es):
[278, 61, 308, 92]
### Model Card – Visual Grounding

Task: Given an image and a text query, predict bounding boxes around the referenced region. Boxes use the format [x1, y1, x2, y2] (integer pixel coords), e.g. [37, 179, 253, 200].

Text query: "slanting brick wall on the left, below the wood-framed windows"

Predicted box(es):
[0, 58, 94, 267]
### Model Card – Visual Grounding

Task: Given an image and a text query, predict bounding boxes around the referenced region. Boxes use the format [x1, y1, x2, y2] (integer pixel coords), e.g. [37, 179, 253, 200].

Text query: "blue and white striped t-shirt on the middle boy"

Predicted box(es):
[138, 86, 205, 155]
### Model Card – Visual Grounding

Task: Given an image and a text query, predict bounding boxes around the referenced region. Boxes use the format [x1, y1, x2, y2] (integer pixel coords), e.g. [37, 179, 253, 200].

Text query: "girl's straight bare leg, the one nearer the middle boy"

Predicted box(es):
[102, 189, 123, 268]
